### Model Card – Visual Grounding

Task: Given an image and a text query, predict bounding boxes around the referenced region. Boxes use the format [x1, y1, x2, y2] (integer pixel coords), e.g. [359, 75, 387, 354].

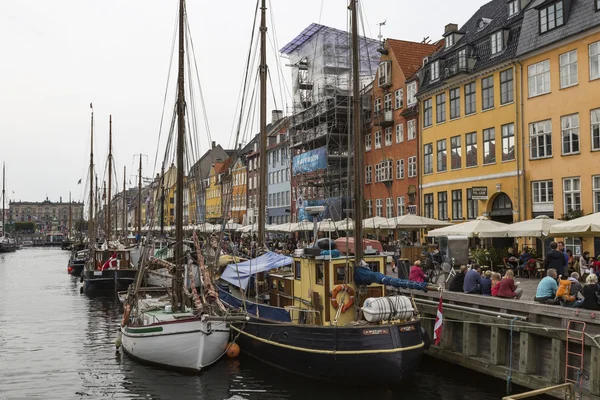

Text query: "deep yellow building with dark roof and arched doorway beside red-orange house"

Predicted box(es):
[417, 0, 526, 223]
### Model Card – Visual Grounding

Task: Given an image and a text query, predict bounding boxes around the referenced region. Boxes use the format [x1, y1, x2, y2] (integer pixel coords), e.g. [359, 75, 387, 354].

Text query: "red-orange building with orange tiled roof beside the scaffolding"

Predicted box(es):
[364, 39, 436, 218]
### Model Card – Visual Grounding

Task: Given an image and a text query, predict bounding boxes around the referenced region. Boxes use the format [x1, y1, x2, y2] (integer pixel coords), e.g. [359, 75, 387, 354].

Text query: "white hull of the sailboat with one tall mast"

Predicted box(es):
[121, 318, 229, 373]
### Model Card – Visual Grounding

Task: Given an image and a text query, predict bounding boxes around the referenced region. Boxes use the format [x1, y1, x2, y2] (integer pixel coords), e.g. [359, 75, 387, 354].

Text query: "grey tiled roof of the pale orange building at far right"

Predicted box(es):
[517, 0, 600, 57]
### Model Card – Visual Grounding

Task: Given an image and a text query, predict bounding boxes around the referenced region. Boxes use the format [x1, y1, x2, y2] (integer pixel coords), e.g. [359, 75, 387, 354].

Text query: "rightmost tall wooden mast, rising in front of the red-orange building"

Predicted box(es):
[350, 0, 363, 265]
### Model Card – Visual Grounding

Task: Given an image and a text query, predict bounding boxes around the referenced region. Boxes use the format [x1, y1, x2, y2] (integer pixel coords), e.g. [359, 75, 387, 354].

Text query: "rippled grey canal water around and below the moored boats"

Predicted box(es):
[0, 248, 524, 400]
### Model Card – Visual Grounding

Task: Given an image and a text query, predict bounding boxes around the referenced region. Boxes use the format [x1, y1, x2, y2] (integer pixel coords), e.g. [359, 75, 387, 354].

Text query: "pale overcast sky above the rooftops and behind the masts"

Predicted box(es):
[0, 0, 483, 205]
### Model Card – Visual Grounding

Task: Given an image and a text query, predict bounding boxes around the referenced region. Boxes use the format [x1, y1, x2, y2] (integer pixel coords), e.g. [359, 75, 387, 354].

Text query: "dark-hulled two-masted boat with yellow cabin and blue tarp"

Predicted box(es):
[219, 0, 431, 387]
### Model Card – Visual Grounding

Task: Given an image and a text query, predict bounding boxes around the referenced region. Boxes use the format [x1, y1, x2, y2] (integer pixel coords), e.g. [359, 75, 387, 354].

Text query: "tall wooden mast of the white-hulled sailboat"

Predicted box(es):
[171, 0, 185, 311]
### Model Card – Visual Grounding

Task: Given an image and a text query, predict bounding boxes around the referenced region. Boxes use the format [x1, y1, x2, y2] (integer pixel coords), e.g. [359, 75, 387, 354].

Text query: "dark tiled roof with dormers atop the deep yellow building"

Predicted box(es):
[419, 0, 523, 93]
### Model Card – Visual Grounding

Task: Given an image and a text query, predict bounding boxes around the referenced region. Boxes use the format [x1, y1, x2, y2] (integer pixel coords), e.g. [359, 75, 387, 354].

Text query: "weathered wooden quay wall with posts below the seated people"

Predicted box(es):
[400, 282, 600, 400]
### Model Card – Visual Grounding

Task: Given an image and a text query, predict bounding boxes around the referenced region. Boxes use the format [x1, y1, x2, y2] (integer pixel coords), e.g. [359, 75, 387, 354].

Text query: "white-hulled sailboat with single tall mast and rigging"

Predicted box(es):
[116, 0, 239, 372]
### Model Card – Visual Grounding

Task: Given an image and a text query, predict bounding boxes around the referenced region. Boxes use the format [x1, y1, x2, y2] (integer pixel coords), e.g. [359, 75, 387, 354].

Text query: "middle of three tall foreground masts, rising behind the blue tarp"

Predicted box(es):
[258, 0, 267, 248]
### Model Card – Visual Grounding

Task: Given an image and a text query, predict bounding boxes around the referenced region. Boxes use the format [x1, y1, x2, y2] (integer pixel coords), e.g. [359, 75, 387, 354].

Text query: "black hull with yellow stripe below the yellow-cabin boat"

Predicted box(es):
[232, 319, 425, 387]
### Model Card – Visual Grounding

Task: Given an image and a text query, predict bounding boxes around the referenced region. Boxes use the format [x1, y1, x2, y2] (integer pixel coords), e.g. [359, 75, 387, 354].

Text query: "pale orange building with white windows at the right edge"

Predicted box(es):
[517, 0, 600, 254]
